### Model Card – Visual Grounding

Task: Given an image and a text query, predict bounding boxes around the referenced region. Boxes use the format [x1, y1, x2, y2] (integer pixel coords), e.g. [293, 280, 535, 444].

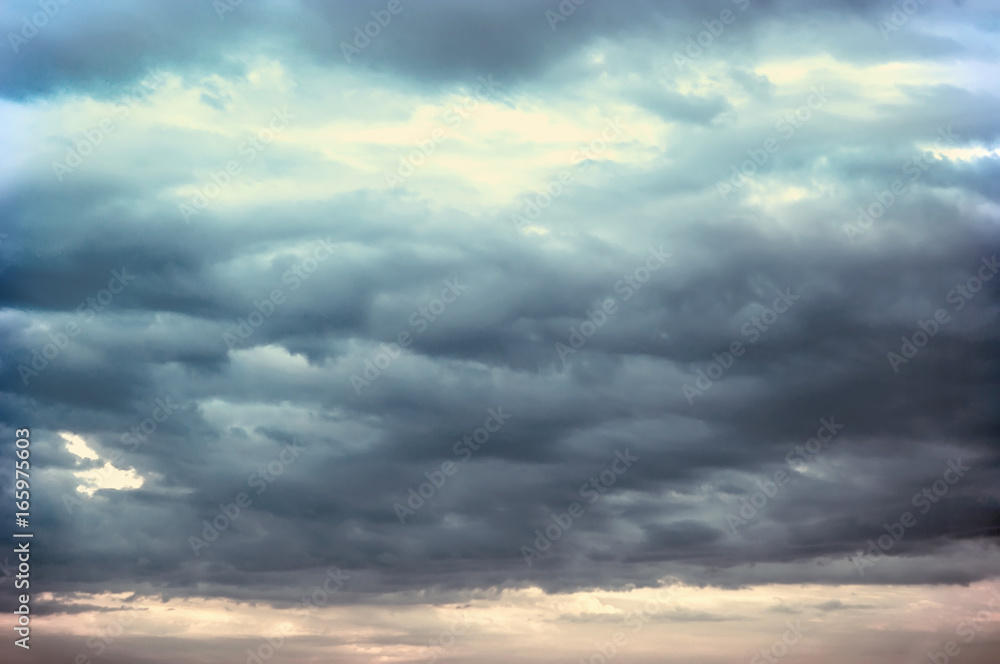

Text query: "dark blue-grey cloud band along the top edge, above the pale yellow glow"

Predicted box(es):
[0, 0, 996, 99]
